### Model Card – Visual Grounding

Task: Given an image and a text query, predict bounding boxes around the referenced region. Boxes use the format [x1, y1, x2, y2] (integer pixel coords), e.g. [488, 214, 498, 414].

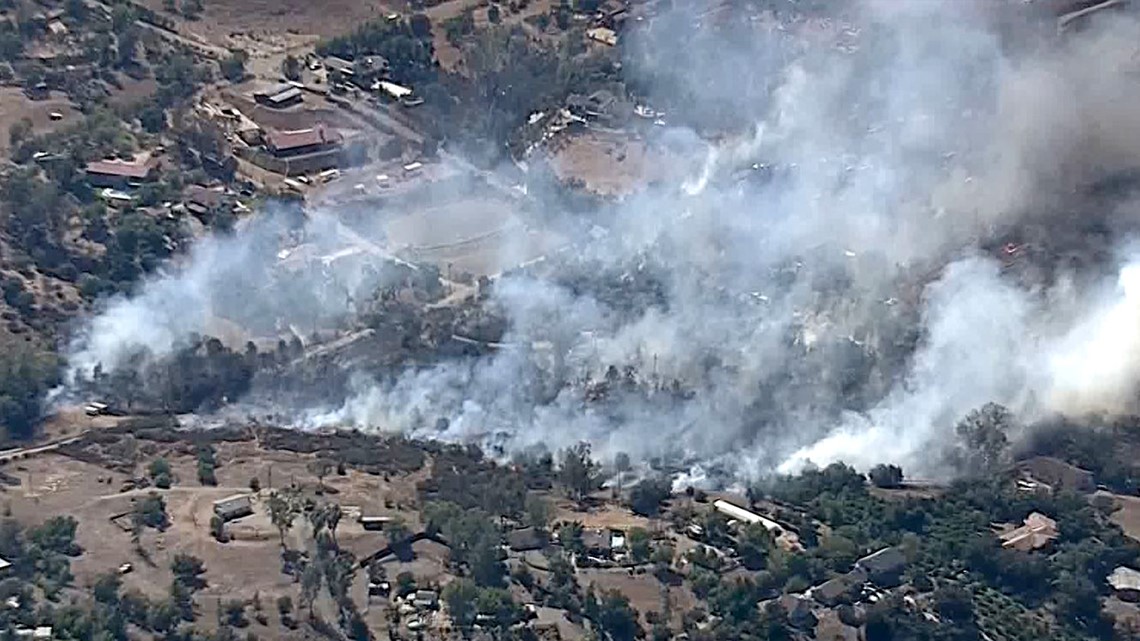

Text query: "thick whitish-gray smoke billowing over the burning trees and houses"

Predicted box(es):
[60, 1, 1140, 477]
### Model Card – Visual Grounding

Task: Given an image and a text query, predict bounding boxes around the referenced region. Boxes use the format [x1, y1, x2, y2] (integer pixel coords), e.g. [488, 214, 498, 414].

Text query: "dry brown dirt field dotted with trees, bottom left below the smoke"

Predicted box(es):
[0, 437, 426, 638]
